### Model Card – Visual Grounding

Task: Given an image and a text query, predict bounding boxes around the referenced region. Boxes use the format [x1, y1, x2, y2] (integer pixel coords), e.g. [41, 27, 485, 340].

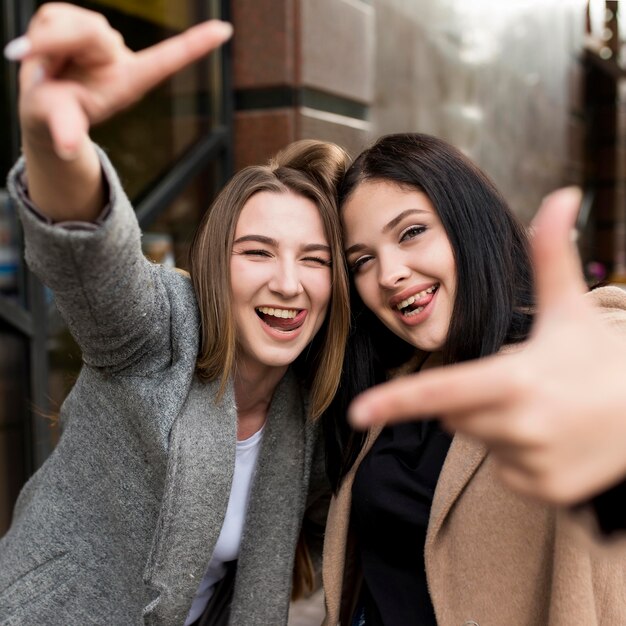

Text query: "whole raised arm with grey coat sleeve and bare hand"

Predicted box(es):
[5, 3, 231, 372]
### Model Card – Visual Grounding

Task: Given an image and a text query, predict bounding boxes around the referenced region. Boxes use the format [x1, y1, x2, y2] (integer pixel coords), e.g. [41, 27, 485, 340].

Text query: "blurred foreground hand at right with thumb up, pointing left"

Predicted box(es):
[350, 189, 626, 504]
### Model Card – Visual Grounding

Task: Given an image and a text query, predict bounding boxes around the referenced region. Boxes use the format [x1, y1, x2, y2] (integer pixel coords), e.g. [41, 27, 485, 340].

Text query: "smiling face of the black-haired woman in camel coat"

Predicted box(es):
[342, 181, 456, 352]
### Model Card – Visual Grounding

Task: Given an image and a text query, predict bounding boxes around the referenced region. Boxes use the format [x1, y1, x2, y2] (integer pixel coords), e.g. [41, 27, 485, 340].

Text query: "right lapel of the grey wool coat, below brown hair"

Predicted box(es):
[230, 372, 317, 626]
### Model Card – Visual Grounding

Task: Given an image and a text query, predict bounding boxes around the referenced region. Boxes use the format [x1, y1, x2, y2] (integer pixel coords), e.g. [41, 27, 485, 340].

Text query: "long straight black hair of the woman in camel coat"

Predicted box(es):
[323, 133, 534, 489]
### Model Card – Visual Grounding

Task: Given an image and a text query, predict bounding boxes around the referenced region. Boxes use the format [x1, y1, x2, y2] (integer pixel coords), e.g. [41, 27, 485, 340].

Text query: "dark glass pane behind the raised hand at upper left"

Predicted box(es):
[62, 0, 222, 202]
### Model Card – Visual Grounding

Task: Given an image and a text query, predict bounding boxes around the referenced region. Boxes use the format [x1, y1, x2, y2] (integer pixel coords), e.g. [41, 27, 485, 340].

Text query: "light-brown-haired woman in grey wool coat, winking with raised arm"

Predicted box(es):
[0, 3, 348, 626]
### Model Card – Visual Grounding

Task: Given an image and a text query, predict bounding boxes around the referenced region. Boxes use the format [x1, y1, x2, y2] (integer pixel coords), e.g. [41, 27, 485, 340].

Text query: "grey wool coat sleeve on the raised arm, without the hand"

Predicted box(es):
[8, 150, 170, 373]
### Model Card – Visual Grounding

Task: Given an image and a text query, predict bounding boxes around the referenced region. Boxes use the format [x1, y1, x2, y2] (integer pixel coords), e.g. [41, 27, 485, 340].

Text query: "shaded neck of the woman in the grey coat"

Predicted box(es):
[233, 362, 287, 440]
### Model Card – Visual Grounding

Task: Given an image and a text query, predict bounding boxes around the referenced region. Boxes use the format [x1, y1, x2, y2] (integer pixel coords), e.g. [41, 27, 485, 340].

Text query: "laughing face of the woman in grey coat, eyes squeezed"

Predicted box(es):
[230, 191, 331, 371]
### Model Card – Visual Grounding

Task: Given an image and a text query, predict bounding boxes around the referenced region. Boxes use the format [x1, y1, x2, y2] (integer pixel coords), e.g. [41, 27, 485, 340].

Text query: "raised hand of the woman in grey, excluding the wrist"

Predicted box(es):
[5, 3, 232, 159]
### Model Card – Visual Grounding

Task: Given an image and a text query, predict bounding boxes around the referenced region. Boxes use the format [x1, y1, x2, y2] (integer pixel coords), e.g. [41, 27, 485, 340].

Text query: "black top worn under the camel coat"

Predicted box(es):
[352, 421, 452, 626]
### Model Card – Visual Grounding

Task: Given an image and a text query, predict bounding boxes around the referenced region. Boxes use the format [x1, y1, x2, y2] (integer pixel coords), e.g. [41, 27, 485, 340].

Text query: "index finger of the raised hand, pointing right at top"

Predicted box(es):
[133, 20, 233, 92]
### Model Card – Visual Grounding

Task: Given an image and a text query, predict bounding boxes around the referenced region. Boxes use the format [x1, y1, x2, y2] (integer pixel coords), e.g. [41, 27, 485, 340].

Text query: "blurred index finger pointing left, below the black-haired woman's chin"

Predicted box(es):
[348, 355, 523, 428]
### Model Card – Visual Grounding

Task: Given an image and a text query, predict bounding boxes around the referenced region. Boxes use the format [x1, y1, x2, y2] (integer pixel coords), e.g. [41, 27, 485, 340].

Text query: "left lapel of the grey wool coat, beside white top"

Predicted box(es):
[144, 378, 237, 625]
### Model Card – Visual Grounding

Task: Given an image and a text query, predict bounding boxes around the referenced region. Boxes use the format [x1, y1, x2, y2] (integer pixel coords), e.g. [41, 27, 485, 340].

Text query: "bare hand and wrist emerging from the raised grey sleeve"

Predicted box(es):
[5, 3, 232, 222]
